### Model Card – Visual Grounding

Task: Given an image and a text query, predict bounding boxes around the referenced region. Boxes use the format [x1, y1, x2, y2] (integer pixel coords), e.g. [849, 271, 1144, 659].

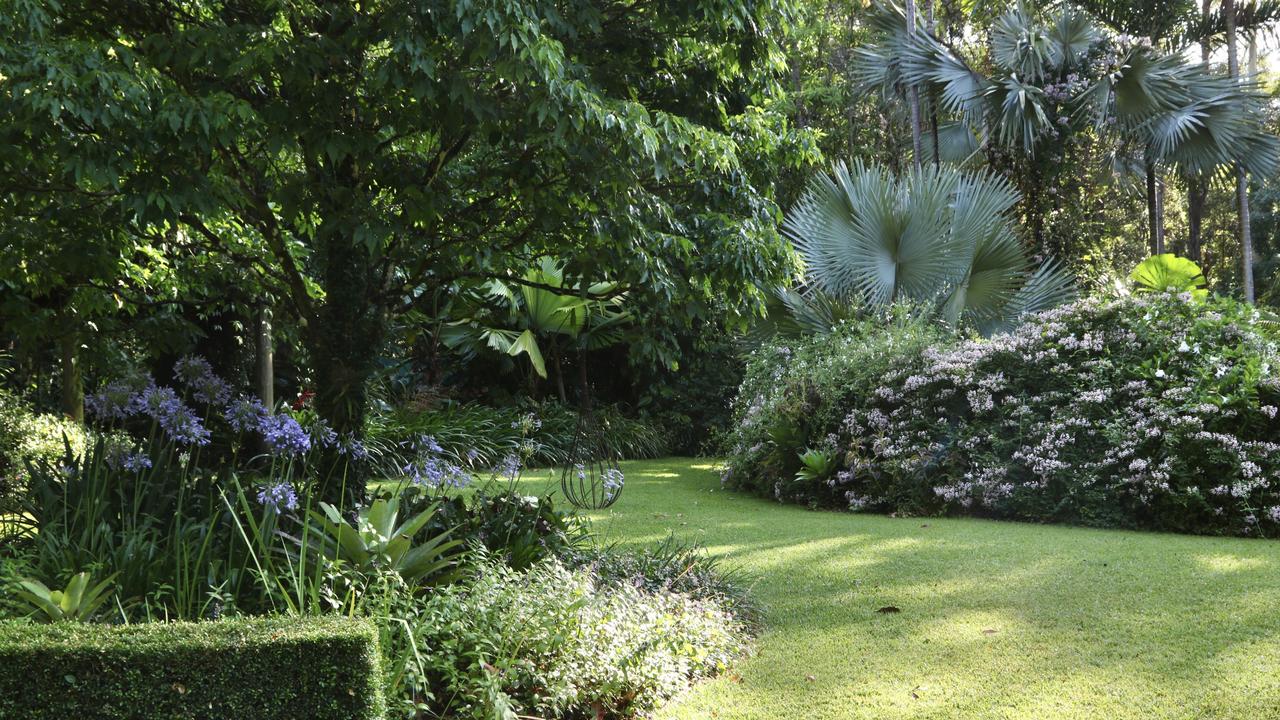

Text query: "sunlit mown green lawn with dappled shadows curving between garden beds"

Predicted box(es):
[531, 459, 1280, 720]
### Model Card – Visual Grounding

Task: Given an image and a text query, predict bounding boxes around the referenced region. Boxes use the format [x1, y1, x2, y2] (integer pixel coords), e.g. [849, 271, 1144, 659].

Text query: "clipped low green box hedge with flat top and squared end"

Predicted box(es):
[0, 618, 385, 720]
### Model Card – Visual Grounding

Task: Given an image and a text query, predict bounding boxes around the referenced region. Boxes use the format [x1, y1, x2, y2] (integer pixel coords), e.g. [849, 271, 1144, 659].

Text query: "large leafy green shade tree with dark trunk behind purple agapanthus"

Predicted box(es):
[0, 0, 790, 492]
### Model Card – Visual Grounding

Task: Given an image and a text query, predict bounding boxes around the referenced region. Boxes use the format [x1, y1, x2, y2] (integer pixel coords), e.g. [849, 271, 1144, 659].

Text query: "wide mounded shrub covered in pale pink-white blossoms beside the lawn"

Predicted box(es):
[726, 293, 1280, 536]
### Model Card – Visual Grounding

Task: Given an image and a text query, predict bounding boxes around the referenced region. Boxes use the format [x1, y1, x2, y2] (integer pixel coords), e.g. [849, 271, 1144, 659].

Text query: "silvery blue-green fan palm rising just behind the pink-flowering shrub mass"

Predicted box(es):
[783, 161, 1073, 332]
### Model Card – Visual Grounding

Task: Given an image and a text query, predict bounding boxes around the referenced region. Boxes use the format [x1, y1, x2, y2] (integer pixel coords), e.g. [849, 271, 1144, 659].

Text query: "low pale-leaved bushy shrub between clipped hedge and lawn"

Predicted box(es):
[394, 559, 745, 720]
